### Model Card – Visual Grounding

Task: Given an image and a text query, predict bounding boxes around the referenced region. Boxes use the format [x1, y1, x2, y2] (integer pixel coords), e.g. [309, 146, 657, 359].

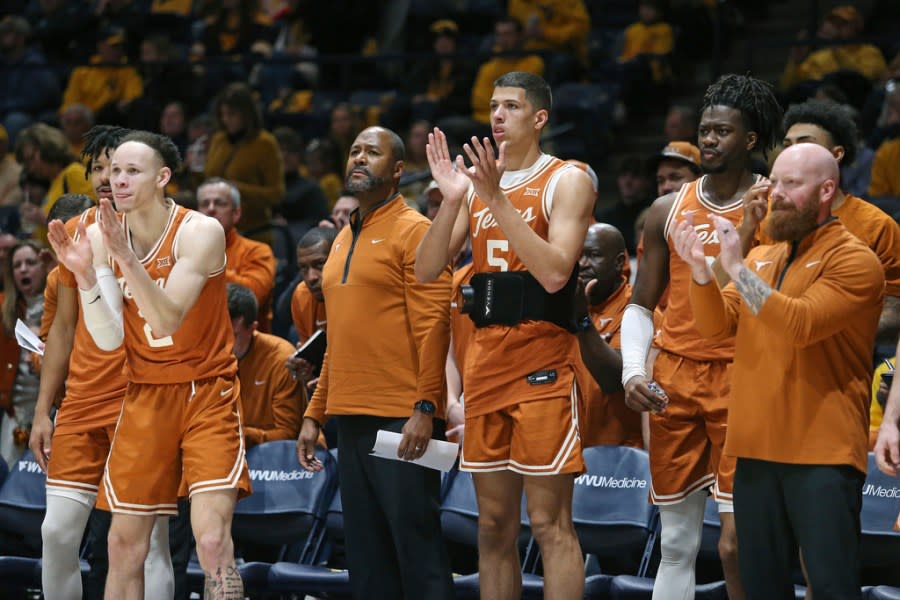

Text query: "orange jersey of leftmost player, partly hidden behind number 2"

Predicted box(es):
[56, 207, 128, 433]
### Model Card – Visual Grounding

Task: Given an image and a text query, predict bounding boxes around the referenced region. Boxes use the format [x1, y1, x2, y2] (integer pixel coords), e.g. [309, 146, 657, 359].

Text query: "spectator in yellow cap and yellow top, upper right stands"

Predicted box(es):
[781, 4, 886, 91]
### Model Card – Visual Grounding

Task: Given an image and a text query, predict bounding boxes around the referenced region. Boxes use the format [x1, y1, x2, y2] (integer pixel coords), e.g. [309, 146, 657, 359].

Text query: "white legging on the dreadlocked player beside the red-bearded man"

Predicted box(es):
[653, 490, 707, 600]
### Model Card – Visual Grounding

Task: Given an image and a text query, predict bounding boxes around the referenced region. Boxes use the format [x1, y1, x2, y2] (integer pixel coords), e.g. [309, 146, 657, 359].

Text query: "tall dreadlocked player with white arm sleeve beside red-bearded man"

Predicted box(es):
[622, 75, 782, 600]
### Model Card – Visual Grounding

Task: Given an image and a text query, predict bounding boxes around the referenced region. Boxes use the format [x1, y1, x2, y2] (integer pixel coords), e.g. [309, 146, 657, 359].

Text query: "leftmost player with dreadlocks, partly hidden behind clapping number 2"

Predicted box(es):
[29, 125, 174, 600]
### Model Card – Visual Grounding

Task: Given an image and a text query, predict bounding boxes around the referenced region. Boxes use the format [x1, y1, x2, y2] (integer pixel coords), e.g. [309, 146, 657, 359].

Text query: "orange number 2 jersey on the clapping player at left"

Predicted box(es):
[116, 201, 237, 384]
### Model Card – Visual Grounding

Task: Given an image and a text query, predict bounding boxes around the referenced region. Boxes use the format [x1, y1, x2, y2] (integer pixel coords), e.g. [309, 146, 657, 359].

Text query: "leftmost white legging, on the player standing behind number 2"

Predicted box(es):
[41, 491, 95, 600]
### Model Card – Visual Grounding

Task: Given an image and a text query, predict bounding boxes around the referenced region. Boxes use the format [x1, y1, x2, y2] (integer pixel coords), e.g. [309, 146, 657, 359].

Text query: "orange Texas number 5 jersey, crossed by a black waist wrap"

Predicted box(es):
[462, 154, 578, 416]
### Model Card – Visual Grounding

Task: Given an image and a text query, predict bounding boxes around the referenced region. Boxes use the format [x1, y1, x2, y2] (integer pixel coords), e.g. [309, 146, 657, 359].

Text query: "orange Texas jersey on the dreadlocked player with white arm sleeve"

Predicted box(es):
[657, 176, 744, 360]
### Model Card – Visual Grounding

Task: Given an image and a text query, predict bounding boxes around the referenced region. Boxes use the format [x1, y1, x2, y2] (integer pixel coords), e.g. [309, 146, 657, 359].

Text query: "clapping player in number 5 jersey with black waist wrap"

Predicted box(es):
[416, 72, 594, 600]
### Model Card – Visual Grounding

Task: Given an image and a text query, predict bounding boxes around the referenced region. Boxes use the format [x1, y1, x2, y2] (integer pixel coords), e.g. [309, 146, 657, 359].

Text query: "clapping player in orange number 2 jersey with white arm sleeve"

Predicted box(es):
[51, 132, 250, 599]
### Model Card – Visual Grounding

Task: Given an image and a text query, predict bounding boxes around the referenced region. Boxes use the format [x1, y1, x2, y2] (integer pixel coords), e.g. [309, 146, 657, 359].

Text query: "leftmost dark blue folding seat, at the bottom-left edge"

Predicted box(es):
[0, 450, 47, 596]
